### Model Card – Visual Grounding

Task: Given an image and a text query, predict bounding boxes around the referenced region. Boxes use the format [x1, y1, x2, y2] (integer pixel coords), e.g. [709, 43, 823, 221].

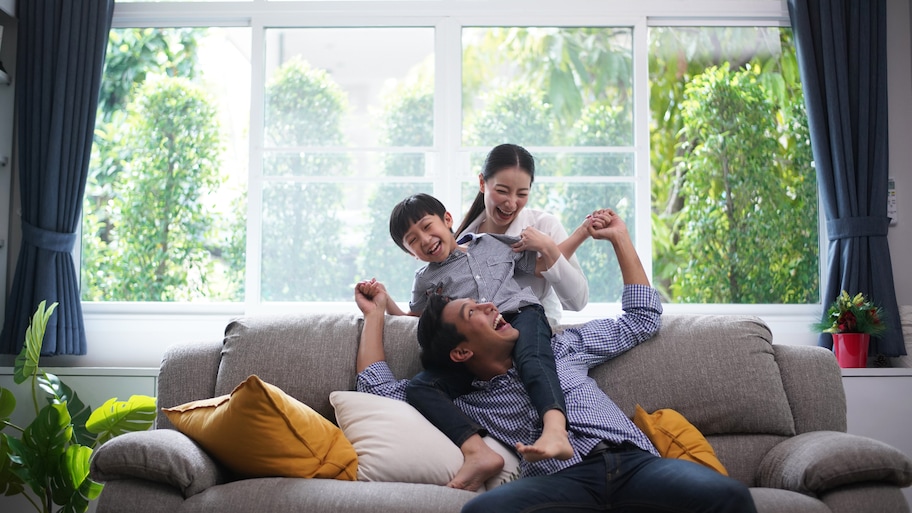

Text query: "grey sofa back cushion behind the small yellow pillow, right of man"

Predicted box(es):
[591, 315, 795, 436]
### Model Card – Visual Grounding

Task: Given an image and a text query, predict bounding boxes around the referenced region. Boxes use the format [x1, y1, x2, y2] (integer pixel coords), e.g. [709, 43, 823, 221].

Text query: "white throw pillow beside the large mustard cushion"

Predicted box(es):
[329, 391, 519, 490]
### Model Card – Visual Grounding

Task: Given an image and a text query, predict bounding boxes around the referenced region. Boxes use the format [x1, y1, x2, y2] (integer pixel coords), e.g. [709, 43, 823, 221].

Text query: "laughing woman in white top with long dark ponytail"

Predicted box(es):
[456, 144, 589, 327]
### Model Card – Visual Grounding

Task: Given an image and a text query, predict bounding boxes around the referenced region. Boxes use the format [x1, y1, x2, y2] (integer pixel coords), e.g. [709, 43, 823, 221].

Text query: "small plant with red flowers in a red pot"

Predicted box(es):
[814, 290, 887, 367]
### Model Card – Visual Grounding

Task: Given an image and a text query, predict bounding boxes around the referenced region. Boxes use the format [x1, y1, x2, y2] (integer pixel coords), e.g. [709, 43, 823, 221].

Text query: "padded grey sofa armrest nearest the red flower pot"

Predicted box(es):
[758, 431, 912, 496]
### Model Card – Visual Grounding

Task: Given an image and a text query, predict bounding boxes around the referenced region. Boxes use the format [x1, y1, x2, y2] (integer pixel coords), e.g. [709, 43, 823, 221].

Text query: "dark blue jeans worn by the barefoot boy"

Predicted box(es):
[406, 305, 567, 446]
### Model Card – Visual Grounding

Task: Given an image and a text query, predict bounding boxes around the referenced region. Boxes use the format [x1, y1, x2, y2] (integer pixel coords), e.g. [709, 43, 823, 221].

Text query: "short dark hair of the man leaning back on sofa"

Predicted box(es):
[418, 294, 466, 369]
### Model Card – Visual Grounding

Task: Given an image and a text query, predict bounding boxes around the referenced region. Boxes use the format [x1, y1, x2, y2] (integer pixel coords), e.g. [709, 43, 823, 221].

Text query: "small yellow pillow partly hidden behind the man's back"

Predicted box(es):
[633, 404, 728, 476]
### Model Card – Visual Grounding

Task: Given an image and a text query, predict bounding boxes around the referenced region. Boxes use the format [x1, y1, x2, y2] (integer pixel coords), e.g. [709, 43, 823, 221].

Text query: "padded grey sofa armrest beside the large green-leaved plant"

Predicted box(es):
[90, 429, 228, 498]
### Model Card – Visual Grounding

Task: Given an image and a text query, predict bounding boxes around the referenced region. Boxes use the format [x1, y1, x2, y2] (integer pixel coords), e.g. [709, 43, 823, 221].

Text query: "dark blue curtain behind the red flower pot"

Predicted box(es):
[788, 0, 906, 356]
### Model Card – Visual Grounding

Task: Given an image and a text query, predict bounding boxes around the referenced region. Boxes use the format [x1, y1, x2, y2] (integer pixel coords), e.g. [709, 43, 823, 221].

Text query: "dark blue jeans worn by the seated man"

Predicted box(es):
[462, 443, 757, 513]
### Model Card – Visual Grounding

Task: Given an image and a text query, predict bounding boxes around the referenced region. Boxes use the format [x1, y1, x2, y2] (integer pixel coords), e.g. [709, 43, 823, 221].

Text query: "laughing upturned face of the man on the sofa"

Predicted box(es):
[443, 298, 519, 358]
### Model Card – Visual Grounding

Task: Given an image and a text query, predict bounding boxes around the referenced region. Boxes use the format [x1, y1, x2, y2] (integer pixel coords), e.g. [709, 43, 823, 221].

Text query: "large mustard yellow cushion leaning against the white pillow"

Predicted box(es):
[162, 376, 358, 481]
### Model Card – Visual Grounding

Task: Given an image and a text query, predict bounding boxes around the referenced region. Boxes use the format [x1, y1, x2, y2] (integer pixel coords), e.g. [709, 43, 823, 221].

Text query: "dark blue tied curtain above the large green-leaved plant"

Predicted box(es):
[0, 0, 114, 355]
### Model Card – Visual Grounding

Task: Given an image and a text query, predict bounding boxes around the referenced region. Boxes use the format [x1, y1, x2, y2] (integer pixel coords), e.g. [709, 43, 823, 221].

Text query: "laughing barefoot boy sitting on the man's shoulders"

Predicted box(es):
[372, 194, 590, 487]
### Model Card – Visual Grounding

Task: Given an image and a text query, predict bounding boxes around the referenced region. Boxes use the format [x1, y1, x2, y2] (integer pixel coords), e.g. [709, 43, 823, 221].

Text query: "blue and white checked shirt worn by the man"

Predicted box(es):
[358, 285, 662, 476]
